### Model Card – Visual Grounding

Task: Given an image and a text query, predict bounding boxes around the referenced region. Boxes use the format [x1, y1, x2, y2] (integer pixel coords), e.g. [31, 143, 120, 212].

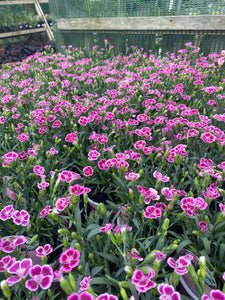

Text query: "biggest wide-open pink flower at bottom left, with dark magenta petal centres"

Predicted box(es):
[25, 265, 53, 292]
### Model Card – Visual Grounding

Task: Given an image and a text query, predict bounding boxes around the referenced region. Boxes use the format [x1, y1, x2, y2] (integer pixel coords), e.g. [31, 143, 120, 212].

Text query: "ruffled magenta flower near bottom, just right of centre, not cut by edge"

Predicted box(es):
[131, 267, 156, 293]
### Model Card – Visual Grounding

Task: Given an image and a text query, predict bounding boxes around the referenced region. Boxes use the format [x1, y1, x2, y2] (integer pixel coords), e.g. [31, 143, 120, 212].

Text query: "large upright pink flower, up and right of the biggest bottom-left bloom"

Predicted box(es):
[59, 248, 80, 272]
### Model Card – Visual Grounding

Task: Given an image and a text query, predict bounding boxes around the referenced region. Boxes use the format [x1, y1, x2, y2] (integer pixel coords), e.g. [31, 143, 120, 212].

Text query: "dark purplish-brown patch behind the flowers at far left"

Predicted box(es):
[0, 40, 56, 65]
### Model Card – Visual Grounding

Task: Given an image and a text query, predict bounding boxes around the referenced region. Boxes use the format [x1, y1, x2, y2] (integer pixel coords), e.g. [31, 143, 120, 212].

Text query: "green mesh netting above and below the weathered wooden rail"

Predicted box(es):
[49, 0, 225, 54]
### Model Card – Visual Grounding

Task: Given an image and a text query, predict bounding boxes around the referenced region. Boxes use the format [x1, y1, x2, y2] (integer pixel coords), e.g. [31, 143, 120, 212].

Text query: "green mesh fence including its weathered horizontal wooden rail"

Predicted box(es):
[49, 0, 225, 55]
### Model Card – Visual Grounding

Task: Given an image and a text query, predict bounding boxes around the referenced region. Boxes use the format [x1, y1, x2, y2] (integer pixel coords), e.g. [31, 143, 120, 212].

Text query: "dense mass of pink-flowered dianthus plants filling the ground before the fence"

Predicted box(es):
[0, 40, 225, 300]
